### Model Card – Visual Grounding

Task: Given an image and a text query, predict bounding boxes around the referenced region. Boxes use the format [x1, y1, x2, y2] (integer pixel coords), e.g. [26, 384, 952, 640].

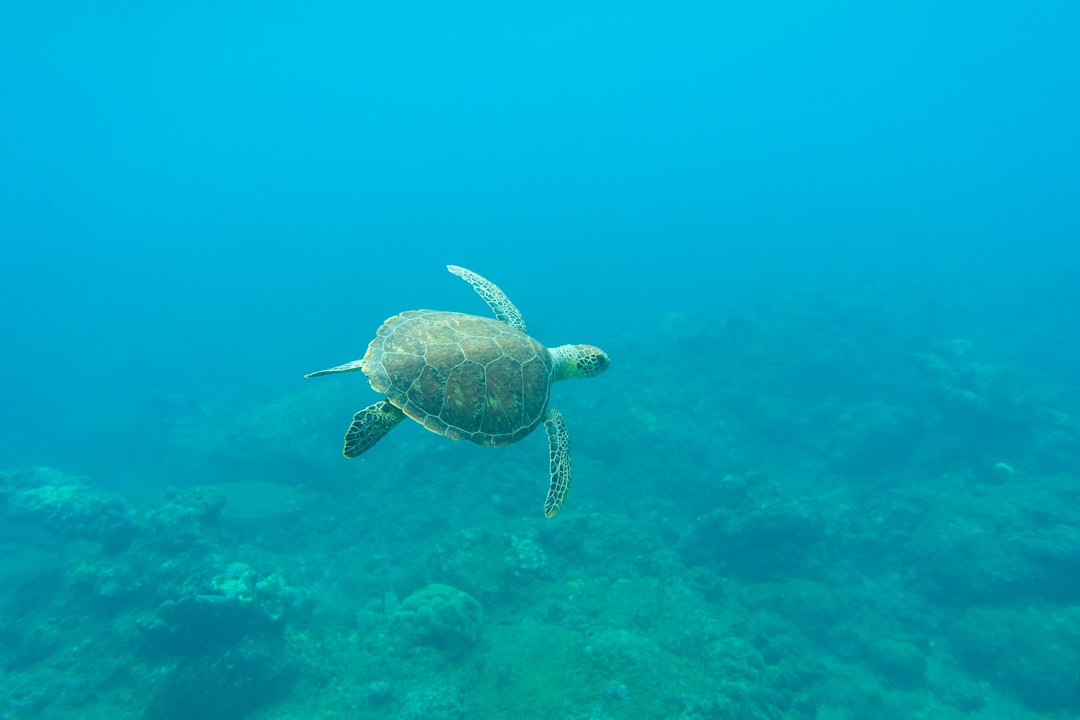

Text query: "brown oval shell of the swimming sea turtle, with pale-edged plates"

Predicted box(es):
[364, 310, 552, 446]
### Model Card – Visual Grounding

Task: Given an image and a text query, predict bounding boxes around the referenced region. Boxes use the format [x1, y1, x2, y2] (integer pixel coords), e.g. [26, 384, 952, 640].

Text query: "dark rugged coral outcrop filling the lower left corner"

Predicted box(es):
[0, 467, 308, 719]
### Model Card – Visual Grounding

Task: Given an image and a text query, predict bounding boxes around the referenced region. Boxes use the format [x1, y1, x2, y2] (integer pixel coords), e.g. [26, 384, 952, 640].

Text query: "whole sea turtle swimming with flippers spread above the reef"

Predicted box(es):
[305, 266, 610, 517]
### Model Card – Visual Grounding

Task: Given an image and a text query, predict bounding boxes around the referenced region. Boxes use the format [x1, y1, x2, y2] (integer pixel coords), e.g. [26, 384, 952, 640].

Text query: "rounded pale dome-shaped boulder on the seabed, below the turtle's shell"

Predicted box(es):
[393, 584, 483, 656]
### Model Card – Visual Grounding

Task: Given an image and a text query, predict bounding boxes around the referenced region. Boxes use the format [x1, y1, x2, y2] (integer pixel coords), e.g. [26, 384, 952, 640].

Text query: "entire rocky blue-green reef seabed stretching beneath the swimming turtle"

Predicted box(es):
[0, 287, 1080, 720]
